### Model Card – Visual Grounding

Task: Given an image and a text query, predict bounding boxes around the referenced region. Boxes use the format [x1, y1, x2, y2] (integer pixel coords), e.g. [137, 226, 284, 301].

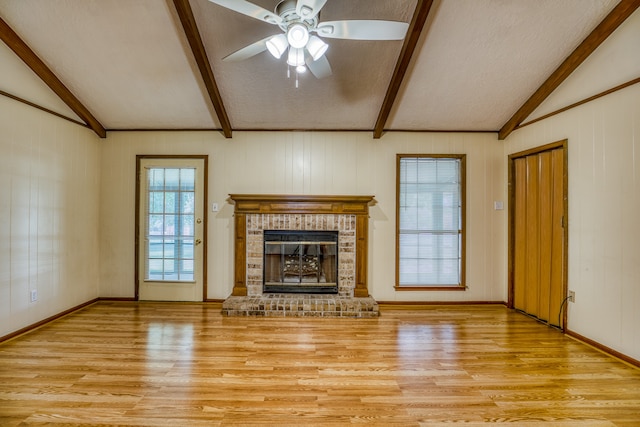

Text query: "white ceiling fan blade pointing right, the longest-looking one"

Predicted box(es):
[317, 19, 409, 40]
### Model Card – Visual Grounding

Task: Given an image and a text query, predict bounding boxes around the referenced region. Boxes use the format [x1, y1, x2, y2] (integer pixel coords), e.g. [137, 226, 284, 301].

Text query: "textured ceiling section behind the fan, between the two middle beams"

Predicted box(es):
[191, 0, 415, 129]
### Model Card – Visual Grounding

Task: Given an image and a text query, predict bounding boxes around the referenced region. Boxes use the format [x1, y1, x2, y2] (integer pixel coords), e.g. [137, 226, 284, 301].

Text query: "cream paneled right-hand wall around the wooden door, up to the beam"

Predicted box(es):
[506, 11, 640, 360]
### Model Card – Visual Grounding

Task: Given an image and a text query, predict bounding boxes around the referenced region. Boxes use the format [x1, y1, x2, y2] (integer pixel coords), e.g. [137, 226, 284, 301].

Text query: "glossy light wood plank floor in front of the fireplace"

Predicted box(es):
[0, 302, 640, 427]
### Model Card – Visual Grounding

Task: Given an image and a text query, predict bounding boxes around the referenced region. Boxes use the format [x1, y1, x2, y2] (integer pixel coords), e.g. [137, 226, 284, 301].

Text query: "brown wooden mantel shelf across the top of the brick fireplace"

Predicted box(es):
[229, 194, 374, 215]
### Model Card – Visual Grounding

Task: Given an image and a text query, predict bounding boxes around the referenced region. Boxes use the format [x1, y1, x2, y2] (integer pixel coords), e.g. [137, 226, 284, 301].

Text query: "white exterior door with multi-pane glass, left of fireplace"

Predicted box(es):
[138, 158, 205, 301]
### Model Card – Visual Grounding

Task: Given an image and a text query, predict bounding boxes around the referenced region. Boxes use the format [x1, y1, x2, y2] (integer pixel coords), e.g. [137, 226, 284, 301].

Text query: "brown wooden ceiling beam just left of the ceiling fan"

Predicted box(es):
[173, 0, 232, 138]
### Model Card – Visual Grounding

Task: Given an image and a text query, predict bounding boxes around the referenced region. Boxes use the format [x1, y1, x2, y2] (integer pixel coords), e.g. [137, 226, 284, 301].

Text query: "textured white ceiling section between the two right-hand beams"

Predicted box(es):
[387, 0, 617, 130]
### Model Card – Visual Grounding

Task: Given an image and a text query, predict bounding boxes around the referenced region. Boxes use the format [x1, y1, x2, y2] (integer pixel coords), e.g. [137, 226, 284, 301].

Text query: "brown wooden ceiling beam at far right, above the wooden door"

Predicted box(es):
[498, 0, 640, 140]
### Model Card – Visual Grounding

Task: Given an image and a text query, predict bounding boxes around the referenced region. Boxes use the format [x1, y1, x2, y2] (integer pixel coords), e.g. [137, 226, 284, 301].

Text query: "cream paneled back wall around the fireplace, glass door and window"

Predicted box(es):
[100, 132, 506, 301]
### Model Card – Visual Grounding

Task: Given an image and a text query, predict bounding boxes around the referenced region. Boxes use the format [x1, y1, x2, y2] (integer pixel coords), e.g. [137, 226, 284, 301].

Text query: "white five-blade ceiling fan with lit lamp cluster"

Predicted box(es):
[209, 0, 409, 81]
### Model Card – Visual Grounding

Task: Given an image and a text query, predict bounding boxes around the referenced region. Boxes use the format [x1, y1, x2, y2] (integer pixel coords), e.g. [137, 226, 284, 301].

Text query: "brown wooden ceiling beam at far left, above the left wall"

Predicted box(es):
[0, 18, 107, 138]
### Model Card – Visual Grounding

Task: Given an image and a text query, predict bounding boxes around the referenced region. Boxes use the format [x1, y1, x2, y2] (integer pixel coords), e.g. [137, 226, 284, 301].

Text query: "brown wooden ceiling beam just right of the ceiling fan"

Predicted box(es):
[373, 0, 433, 139]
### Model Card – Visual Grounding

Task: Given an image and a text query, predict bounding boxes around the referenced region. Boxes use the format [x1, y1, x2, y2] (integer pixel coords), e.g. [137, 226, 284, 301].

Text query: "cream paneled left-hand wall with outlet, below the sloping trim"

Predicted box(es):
[0, 96, 100, 336]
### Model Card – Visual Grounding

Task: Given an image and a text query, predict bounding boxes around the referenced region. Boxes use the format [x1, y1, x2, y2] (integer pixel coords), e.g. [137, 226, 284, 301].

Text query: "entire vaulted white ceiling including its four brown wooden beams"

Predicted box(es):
[0, 0, 640, 138]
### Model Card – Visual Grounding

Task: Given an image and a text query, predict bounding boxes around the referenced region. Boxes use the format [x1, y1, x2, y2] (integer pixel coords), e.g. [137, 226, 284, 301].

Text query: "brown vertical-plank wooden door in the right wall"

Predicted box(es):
[511, 147, 566, 326]
